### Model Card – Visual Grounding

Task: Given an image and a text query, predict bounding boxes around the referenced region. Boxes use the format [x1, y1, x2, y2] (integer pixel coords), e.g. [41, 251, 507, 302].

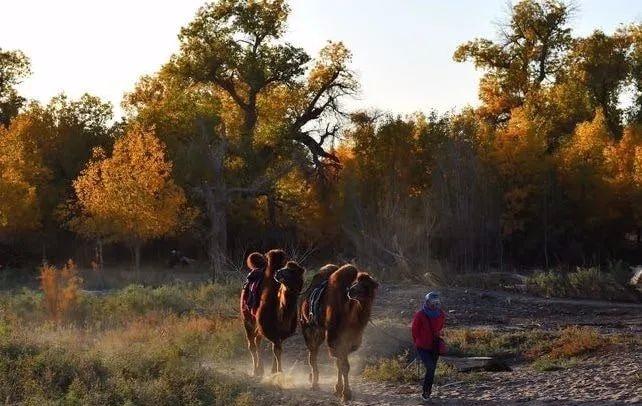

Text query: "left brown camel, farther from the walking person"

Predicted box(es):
[243, 250, 304, 376]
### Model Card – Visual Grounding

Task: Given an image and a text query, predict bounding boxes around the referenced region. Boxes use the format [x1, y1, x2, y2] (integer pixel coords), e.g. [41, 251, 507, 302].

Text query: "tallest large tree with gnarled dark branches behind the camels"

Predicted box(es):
[125, 0, 357, 276]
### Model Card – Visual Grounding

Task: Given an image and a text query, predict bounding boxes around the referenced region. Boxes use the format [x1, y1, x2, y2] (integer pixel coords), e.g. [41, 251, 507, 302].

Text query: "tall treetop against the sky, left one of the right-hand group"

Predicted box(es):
[453, 0, 572, 121]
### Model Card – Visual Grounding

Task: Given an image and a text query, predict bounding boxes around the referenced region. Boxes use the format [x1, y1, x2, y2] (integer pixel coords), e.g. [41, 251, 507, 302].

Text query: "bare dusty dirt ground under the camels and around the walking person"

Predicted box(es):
[220, 285, 642, 405]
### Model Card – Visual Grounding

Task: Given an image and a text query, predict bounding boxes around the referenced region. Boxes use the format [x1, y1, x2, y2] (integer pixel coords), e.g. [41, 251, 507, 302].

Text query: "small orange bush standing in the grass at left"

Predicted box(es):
[40, 260, 82, 321]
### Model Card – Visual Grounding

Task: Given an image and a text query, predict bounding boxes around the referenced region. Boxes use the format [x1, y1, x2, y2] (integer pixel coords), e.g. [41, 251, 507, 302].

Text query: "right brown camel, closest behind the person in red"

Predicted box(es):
[300, 265, 379, 400]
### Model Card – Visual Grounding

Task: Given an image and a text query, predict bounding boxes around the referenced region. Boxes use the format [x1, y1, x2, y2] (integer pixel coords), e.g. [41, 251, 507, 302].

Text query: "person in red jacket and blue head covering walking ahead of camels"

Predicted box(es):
[412, 292, 446, 401]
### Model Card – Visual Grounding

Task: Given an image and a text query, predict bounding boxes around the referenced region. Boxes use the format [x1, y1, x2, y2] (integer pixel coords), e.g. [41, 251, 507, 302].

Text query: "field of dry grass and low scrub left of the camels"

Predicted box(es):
[0, 284, 252, 406]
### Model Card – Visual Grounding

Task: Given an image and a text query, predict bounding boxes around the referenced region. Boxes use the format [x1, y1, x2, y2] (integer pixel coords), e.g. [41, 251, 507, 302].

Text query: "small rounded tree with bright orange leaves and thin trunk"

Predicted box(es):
[69, 129, 192, 270]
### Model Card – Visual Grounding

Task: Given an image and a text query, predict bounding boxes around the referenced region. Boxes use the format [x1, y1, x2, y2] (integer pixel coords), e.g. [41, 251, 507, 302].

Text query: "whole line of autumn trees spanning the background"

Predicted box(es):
[0, 0, 642, 277]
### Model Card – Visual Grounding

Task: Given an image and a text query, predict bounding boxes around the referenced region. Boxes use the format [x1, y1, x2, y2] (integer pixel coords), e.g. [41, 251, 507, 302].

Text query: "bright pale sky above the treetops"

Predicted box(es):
[0, 0, 642, 119]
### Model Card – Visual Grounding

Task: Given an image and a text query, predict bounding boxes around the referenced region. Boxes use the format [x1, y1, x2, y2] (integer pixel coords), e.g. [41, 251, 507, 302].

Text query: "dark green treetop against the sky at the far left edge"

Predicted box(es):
[0, 48, 31, 126]
